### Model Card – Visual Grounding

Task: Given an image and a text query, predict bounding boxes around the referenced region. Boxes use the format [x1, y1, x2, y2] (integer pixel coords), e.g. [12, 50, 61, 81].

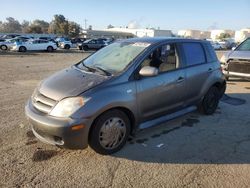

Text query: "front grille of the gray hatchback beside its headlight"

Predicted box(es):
[32, 91, 56, 114]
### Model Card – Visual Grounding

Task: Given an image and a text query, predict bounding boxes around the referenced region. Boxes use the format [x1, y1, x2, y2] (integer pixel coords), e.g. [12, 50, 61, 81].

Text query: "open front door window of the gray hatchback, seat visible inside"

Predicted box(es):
[141, 44, 179, 73]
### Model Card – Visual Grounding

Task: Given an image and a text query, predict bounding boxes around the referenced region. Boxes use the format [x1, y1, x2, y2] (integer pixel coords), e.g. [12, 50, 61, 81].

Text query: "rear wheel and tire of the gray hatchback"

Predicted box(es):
[198, 86, 220, 115]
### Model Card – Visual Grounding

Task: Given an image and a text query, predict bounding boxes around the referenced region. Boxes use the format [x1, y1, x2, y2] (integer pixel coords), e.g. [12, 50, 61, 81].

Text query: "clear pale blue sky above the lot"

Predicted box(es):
[0, 0, 250, 32]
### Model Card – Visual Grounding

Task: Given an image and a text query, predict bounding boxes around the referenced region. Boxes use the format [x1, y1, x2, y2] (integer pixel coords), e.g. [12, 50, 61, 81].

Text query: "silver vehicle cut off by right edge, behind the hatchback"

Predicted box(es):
[220, 38, 250, 79]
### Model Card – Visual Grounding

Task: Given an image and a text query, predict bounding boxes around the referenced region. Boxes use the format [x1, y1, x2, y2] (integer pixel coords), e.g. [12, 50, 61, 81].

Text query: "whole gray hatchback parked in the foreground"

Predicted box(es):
[25, 38, 226, 154]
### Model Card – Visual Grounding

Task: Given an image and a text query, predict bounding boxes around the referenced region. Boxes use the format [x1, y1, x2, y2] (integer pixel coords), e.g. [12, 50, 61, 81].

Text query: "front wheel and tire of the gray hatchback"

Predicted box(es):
[89, 110, 131, 155]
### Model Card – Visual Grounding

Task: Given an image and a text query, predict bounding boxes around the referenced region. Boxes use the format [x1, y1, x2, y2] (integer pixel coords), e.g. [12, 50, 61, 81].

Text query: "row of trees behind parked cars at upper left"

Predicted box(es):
[0, 14, 82, 37]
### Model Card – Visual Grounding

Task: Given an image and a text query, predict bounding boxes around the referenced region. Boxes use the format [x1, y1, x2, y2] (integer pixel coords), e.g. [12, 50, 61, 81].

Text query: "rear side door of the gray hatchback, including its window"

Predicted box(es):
[182, 42, 213, 104]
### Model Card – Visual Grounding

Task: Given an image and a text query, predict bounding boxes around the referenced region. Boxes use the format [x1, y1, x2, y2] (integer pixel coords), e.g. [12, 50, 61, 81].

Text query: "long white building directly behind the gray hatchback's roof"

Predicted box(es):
[105, 28, 173, 37]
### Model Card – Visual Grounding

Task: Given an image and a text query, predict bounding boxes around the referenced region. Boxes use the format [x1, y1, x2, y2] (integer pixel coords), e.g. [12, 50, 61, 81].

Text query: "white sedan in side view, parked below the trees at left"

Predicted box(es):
[10, 39, 57, 52]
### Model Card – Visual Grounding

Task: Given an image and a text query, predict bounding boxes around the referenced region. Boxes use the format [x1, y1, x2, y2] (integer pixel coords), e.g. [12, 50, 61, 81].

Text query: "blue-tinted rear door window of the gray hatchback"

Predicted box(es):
[182, 42, 206, 66]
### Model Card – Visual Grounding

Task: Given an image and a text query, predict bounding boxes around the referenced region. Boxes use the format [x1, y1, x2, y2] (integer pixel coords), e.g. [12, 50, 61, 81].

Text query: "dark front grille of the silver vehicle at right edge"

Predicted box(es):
[228, 59, 250, 74]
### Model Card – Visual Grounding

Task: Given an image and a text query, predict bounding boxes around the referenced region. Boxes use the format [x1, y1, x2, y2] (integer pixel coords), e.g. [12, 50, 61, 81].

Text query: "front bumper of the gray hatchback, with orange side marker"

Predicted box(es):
[25, 100, 91, 149]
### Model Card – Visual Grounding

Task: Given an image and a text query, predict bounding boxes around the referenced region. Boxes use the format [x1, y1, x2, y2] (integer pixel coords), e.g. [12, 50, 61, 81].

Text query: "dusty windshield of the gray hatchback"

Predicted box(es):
[79, 42, 150, 74]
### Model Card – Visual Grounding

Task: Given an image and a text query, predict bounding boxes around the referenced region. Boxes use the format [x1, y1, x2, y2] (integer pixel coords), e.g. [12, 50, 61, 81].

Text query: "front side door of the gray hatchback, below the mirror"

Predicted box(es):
[136, 44, 186, 121]
